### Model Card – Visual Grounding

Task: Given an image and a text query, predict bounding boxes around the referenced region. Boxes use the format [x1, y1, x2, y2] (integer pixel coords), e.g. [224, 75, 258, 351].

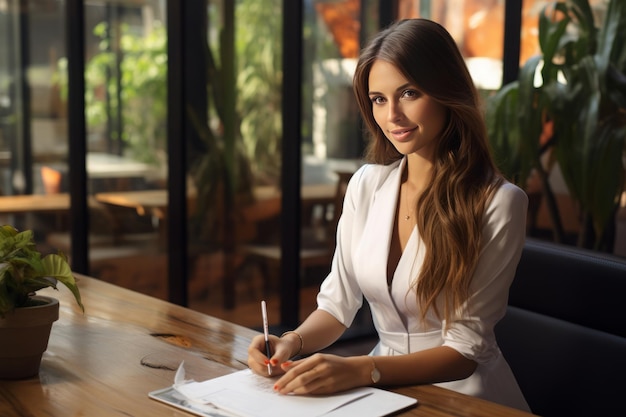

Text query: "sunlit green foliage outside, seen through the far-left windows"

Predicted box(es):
[56, 21, 167, 166]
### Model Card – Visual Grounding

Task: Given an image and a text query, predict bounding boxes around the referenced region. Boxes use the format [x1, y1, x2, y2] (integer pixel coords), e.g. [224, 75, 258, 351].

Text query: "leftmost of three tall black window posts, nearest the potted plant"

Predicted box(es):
[65, 0, 89, 274]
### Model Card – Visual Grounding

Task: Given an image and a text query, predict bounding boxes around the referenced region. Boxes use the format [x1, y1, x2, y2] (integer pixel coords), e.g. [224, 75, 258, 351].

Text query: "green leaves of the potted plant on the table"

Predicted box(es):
[0, 225, 84, 317]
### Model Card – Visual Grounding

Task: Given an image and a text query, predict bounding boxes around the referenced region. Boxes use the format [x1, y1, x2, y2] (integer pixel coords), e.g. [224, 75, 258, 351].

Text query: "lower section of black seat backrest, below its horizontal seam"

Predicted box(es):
[495, 306, 626, 417]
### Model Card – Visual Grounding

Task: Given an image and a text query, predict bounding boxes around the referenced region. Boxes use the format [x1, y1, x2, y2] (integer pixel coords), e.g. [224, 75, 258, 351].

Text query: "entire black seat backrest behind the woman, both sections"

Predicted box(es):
[495, 238, 626, 417]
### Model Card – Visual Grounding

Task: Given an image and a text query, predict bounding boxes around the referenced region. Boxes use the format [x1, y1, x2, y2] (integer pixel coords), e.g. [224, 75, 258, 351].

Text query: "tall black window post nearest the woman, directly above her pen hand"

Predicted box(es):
[280, 0, 303, 328]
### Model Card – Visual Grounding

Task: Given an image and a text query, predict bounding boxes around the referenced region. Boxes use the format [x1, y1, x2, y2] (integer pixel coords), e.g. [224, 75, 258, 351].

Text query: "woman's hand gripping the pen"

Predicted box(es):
[248, 334, 294, 376]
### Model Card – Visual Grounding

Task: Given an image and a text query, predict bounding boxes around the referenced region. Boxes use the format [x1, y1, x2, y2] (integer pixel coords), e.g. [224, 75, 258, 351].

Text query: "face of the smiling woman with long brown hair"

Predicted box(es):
[369, 60, 447, 161]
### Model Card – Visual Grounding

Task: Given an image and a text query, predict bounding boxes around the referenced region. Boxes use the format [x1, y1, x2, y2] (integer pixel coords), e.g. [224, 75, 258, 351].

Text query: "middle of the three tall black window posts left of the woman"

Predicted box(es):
[167, 0, 189, 306]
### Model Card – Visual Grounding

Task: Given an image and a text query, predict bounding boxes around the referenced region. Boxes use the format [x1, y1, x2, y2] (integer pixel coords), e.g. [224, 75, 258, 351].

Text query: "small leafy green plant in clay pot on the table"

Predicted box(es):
[0, 225, 84, 379]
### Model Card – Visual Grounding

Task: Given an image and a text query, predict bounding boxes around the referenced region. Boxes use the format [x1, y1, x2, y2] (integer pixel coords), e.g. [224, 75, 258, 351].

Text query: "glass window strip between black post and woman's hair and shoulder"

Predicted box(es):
[299, 0, 378, 319]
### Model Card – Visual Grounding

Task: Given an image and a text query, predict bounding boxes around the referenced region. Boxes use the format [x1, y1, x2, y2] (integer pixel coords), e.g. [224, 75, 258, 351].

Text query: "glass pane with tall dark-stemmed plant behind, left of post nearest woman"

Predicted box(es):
[188, 0, 282, 326]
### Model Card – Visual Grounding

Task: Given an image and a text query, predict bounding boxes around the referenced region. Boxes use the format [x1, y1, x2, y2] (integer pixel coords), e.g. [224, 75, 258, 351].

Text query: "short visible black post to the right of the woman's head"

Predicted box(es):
[502, 0, 522, 85]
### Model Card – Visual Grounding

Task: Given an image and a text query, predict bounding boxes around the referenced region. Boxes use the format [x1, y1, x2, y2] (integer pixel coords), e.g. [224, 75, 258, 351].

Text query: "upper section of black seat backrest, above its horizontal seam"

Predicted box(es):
[509, 238, 626, 337]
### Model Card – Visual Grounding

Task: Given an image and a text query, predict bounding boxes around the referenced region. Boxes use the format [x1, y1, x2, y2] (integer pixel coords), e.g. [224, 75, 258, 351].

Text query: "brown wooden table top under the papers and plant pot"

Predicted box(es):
[0, 275, 530, 417]
